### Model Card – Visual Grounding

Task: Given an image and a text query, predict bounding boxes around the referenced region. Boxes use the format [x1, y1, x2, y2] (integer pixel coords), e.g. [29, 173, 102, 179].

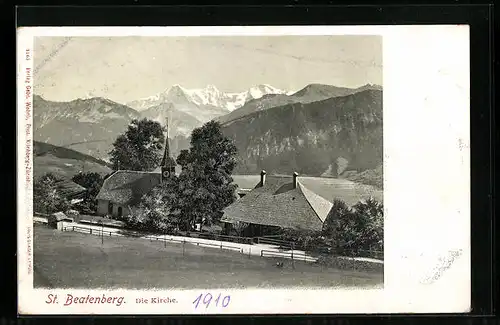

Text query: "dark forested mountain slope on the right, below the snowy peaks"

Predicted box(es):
[222, 89, 383, 177]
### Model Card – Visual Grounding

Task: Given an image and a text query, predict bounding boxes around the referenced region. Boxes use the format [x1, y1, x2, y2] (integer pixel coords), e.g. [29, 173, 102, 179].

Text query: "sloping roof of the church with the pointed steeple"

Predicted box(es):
[97, 170, 161, 206]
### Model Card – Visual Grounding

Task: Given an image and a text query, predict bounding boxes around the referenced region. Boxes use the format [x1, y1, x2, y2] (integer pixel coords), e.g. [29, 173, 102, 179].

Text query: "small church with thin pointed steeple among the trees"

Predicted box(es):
[96, 123, 176, 218]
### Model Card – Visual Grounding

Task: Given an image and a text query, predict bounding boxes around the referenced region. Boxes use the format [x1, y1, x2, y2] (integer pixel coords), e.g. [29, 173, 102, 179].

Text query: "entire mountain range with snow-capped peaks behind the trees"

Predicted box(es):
[33, 84, 382, 187]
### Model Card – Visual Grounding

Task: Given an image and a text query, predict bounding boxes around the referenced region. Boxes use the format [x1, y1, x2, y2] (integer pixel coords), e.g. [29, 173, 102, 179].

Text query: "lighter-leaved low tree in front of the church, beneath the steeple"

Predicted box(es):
[124, 177, 180, 233]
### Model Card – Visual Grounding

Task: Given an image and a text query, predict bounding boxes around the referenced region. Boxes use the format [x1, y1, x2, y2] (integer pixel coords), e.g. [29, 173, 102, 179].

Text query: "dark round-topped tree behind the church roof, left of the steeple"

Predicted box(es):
[109, 119, 165, 171]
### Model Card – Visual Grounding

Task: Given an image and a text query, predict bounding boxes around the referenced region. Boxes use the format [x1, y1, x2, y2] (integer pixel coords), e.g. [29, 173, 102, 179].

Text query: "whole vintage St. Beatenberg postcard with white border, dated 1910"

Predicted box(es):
[17, 25, 471, 315]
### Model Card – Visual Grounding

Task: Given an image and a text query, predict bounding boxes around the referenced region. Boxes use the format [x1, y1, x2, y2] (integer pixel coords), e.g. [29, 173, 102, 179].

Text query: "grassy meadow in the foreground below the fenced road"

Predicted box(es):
[34, 225, 383, 289]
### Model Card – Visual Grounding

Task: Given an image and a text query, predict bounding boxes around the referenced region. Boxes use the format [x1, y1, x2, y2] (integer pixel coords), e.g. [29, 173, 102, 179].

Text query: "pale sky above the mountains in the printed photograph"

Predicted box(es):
[34, 35, 382, 103]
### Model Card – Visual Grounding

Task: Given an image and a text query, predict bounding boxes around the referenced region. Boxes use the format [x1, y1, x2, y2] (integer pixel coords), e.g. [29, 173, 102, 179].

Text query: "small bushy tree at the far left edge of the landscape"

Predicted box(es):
[33, 173, 70, 214]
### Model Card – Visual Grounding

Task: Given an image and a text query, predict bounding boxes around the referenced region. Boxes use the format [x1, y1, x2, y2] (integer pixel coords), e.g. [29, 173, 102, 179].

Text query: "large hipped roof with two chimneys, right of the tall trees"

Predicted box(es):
[221, 176, 332, 230]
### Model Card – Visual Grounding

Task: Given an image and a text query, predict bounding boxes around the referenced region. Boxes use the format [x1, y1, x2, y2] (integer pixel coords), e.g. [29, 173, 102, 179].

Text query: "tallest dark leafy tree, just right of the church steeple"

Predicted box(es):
[177, 121, 237, 229]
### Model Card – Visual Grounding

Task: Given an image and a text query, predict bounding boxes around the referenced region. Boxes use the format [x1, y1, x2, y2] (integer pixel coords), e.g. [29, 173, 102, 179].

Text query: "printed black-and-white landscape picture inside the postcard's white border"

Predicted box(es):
[33, 35, 384, 289]
